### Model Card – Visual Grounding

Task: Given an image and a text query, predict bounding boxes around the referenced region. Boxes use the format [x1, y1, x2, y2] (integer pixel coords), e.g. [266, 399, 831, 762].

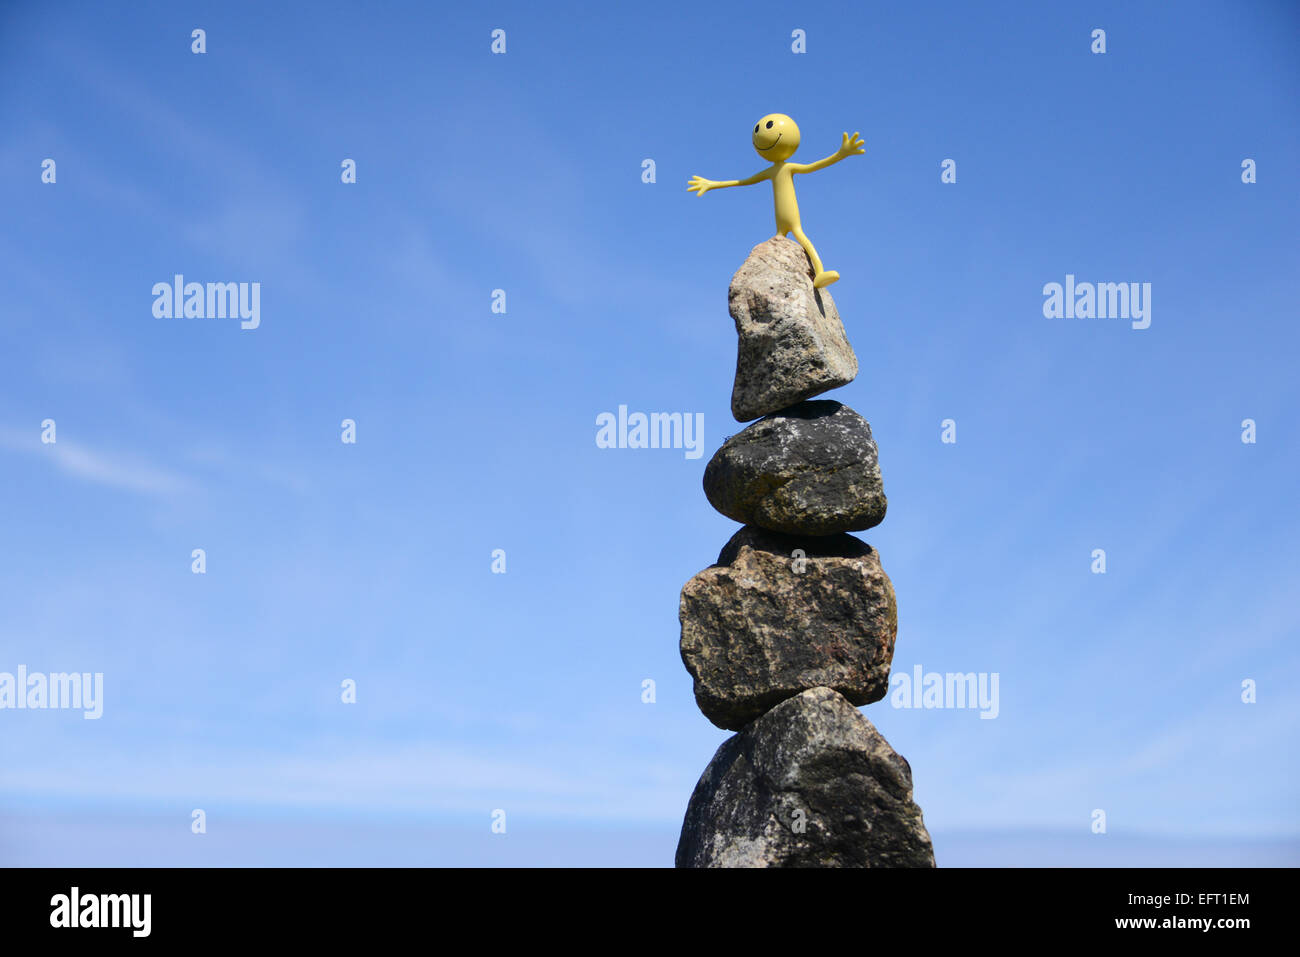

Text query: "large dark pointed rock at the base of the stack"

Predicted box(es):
[676, 688, 935, 867]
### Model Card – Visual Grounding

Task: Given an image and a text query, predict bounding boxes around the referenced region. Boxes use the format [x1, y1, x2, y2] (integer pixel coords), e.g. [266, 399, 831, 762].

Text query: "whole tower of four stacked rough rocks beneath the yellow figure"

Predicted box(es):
[676, 237, 935, 867]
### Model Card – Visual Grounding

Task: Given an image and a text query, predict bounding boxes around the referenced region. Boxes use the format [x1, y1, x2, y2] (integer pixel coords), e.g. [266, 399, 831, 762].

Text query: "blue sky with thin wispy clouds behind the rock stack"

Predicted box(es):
[0, 3, 1300, 866]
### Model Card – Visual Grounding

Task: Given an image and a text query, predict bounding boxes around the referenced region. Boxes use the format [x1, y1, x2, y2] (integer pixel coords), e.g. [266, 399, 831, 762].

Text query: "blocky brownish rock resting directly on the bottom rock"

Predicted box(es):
[679, 527, 898, 731]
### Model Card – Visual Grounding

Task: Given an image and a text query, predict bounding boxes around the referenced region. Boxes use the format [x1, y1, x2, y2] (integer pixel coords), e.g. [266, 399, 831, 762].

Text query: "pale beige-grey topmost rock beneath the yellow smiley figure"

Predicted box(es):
[727, 237, 858, 423]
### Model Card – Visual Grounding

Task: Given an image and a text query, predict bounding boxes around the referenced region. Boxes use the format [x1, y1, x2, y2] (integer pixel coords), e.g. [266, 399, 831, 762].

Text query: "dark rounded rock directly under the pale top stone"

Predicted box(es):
[705, 399, 888, 534]
